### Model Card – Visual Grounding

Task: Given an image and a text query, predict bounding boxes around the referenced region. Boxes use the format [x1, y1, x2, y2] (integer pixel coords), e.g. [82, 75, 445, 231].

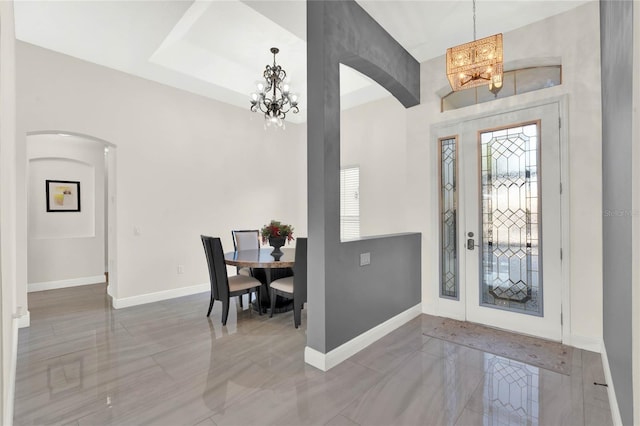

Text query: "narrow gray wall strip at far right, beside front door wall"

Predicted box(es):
[600, 0, 634, 425]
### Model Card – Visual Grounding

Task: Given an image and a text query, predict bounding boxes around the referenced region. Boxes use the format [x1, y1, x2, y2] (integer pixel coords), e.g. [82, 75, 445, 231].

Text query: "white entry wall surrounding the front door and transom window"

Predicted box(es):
[407, 2, 602, 350]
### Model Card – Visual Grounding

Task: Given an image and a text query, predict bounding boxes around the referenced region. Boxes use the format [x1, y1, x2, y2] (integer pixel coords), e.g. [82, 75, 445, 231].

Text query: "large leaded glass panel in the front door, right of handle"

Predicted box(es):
[480, 122, 542, 316]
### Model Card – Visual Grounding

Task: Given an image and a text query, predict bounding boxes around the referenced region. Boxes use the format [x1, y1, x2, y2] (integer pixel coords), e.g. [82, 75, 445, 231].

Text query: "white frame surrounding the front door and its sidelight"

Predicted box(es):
[425, 95, 571, 344]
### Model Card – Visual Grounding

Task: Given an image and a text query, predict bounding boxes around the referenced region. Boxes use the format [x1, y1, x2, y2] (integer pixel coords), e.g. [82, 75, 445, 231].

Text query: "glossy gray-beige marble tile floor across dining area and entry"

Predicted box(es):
[14, 284, 611, 426]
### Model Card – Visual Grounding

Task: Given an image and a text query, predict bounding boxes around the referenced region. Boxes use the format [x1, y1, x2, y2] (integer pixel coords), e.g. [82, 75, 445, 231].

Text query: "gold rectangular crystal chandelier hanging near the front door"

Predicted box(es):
[447, 0, 502, 96]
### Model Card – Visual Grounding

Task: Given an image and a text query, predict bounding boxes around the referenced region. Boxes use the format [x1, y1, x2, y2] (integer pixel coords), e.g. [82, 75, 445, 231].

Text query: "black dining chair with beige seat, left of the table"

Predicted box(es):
[200, 235, 262, 325]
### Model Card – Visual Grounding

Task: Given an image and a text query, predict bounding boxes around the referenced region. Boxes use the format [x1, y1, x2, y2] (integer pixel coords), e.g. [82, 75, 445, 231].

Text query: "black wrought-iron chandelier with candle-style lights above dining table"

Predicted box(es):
[250, 47, 300, 127]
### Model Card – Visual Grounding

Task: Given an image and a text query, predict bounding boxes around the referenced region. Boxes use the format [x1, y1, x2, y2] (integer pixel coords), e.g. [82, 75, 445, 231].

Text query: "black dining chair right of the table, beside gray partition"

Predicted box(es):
[269, 238, 307, 328]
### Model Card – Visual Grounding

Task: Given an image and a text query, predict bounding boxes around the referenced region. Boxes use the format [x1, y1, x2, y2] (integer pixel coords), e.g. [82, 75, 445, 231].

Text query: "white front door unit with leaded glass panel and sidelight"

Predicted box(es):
[436, 103, 562, 340]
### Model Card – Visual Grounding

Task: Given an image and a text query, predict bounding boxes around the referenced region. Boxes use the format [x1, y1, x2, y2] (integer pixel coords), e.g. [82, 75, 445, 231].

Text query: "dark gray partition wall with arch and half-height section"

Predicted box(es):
[307, 0, 421, 353]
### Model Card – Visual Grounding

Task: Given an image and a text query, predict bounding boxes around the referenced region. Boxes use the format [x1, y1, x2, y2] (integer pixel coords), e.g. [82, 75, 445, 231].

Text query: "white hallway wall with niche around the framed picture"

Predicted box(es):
[27, 133, 105, 290]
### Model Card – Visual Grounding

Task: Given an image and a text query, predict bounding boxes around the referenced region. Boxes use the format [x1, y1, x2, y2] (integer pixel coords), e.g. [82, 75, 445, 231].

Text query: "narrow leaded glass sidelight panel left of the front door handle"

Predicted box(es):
[439, 138, 458, 299]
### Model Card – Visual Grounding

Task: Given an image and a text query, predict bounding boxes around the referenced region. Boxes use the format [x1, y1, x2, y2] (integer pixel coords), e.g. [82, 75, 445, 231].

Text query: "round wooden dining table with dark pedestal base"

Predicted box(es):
[224, 247, 296, 313]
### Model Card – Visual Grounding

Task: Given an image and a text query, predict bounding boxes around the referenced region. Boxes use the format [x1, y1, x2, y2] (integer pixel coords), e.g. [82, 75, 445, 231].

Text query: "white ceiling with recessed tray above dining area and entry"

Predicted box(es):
[14, 0, 589, 122]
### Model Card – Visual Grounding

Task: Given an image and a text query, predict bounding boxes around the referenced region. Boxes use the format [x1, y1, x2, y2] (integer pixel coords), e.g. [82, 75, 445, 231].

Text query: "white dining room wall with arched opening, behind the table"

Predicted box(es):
[17, 42, 306, 301]
